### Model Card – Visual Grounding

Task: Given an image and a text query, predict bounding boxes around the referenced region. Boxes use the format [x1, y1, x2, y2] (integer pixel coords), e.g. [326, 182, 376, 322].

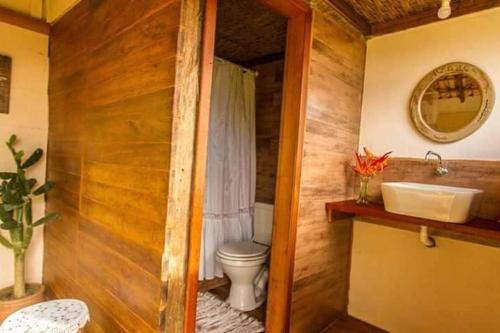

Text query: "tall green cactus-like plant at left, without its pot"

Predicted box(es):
[0, 135, 57, 299]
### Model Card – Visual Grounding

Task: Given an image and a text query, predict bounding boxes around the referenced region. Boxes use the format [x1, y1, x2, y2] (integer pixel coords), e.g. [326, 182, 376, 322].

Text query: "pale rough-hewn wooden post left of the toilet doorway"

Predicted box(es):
[161, 0, 206, 333]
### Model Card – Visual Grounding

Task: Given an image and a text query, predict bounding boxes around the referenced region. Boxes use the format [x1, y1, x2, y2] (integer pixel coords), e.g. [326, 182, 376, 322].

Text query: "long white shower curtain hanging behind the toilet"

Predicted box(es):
[199, 58, 256, 280]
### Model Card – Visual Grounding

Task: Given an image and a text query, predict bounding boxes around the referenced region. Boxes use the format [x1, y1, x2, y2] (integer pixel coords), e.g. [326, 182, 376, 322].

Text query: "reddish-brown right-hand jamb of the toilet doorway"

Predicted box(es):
[266, 11, 312, 333]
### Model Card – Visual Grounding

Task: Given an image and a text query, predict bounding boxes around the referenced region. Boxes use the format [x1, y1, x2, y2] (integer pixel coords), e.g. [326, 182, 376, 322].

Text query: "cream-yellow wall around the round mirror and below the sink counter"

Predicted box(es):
[348, 9, 500, 333]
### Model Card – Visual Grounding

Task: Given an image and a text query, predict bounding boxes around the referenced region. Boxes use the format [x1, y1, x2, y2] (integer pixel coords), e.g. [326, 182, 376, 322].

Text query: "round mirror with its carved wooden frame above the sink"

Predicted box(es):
[410, 63, 494, 142]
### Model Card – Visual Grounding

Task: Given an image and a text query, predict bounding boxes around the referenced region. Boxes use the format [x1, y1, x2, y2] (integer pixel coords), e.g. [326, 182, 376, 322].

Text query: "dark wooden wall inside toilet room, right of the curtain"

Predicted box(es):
[253, 60, 284, 205]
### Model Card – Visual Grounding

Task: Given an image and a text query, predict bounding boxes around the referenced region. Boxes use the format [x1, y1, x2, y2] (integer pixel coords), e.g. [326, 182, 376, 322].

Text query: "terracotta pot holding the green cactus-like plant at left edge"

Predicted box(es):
[0, 283, 45, 324]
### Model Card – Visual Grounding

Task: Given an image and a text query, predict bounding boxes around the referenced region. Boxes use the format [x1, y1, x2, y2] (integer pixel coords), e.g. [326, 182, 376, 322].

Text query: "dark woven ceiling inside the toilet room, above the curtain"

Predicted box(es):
[215, 0, 287, 67]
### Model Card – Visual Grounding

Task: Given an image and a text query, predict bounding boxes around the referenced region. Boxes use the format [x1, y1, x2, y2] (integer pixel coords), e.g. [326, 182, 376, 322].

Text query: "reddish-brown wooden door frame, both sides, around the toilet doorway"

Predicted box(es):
[183, 0, 312, 333]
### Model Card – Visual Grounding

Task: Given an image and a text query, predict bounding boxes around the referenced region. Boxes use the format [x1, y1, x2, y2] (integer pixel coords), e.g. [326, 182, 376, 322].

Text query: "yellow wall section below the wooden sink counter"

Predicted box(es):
[349, 221, 500, 333]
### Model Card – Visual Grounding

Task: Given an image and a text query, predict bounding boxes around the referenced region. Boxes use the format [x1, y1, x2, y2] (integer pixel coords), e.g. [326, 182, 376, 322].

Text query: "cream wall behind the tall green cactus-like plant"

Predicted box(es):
[0, 23, 48, 288]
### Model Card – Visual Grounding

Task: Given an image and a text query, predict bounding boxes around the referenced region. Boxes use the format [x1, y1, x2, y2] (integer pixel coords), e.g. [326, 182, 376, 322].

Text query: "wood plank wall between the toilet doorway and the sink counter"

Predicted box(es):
[291, 1, 366, 333]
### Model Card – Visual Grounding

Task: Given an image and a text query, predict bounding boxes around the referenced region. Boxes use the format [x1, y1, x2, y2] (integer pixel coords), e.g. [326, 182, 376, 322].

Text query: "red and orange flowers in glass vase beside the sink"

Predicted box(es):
[353, 147, 392, 205]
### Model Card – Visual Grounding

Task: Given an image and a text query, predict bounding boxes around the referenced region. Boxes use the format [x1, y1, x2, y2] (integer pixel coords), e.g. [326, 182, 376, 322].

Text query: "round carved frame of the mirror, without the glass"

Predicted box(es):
[410, 62, 495, 143]
